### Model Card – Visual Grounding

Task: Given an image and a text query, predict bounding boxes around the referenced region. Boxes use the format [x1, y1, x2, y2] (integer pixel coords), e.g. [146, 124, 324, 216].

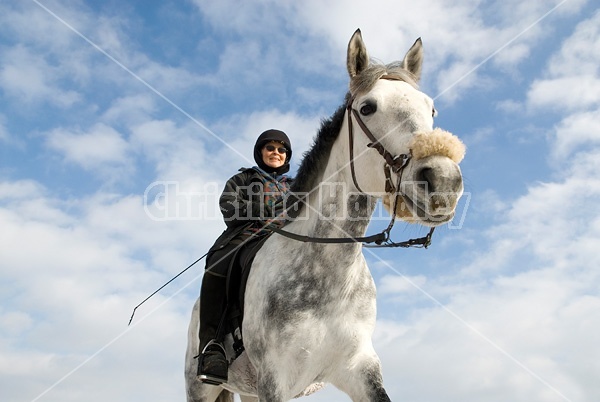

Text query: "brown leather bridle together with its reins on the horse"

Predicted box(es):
[267, 74, 435, 248]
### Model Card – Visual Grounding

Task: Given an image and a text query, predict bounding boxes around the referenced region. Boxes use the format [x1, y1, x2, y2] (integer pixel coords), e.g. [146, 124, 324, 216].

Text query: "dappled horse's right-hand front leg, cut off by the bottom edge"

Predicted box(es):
[332, 354, 390, 402]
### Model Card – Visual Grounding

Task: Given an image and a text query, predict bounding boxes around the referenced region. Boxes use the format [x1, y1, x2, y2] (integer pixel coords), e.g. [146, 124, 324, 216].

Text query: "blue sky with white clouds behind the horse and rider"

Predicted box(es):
[0, 0, 600, 402]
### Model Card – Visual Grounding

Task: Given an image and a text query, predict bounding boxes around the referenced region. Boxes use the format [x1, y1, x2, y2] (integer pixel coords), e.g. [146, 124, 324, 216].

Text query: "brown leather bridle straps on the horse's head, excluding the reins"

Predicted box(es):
[346, 74, 412, 196]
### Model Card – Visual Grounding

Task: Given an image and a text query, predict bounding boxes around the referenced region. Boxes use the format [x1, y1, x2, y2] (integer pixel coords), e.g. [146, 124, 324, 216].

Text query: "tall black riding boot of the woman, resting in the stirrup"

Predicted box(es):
[198, 271, 228, 385]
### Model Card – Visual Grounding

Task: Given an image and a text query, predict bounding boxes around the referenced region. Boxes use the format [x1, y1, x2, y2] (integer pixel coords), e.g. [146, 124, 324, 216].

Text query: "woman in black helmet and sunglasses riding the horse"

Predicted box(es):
[198, 130, 292, 384]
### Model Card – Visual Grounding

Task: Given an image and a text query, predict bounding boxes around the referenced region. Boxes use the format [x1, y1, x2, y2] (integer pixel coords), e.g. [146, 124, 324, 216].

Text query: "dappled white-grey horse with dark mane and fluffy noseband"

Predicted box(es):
[186, 30, 465, 402]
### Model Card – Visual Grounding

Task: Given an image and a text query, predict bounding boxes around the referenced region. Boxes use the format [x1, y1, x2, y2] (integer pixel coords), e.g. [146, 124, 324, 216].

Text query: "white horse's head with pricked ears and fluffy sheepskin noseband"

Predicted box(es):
[347, 30, 465, 227]
